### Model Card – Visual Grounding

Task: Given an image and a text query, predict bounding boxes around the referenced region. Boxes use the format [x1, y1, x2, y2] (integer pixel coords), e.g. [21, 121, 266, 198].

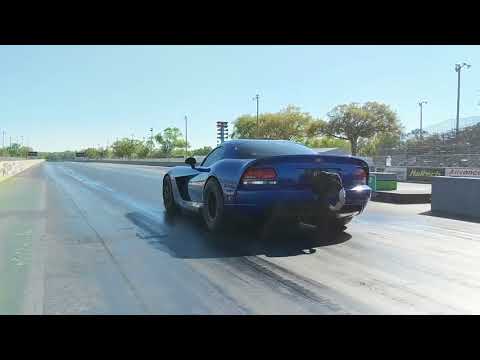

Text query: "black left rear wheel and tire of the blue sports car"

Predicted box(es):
[202, 179, 226, 233]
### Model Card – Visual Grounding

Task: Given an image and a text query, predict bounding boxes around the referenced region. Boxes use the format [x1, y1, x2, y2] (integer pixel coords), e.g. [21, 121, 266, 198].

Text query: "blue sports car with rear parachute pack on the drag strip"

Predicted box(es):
[163, 140, 371, 231]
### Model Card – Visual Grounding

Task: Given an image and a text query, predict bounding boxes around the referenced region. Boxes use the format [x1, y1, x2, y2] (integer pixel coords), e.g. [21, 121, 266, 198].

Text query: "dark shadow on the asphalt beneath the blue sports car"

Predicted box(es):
[126, 212, 351, 259]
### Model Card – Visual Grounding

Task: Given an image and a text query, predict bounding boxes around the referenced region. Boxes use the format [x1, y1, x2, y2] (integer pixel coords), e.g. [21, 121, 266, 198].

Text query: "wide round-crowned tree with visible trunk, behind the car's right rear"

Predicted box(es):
[309, 102, 400, 155]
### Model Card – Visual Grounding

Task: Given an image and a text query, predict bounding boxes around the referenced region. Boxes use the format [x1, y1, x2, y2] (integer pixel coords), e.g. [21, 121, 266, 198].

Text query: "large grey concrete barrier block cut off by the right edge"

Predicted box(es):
[432, 176, 480, 219]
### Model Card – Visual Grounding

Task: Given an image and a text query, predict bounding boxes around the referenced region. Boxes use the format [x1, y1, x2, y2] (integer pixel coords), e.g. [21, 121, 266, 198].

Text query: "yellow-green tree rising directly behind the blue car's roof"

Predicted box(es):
[232, 105, 314, 142]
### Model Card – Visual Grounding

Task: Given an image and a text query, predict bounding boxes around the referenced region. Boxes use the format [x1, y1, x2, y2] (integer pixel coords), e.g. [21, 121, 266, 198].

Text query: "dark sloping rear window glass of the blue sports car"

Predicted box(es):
[231, 141, 316, 159]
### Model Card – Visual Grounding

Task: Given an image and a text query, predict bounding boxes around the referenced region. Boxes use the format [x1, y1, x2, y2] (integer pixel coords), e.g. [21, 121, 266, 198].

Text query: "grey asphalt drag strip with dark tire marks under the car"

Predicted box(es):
[0, 162, 480, 314]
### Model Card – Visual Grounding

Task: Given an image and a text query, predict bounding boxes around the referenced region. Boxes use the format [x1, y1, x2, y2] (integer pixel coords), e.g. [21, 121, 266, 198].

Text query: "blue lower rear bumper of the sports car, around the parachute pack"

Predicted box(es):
[225, 185, 372, 217]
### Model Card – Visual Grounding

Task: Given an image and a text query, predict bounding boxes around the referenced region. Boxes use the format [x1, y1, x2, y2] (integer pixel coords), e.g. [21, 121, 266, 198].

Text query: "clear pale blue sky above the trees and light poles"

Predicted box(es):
[0, 45, 480, 151]
